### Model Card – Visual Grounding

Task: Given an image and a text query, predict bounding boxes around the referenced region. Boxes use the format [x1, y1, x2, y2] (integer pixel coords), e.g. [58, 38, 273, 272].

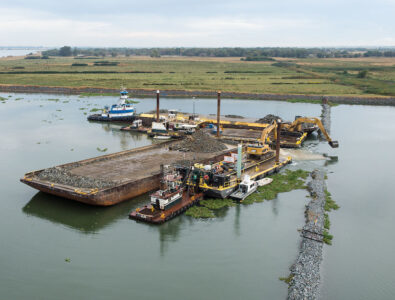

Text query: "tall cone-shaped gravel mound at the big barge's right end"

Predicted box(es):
[170, 130, 227, 153]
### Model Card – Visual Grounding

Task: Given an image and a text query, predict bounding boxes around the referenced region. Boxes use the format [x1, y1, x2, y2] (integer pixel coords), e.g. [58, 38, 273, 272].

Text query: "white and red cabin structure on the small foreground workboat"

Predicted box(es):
[151, 172, 184, 210]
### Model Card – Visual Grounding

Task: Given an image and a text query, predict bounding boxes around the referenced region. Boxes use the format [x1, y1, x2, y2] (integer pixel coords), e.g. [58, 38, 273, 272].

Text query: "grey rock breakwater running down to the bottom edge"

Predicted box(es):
[287, 170, 326, 299]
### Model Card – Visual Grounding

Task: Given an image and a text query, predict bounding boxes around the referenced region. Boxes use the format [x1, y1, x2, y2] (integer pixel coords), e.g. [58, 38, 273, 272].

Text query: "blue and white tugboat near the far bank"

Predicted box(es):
[88, 89, 136, 122]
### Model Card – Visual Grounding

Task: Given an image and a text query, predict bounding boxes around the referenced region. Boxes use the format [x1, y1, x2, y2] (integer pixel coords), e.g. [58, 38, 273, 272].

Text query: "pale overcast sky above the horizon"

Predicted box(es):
[0, 0, 395, 47]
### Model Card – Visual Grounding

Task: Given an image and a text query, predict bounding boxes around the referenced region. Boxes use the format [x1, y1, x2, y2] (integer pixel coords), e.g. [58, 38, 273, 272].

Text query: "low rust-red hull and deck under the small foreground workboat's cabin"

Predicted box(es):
[129, 191, 203, 224]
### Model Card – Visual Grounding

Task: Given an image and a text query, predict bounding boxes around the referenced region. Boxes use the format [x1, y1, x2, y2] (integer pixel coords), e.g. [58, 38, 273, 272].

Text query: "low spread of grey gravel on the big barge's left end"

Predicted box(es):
[37, 167, 117, 189]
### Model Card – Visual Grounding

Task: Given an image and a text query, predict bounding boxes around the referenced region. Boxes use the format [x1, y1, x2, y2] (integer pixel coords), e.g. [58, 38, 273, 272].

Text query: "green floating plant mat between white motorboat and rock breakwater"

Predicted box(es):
[242, 169, 310, 205]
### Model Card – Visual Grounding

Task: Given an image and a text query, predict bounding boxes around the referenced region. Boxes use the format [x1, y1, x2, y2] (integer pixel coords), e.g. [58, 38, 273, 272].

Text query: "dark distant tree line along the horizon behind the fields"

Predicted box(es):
[42, 46, 395, 60]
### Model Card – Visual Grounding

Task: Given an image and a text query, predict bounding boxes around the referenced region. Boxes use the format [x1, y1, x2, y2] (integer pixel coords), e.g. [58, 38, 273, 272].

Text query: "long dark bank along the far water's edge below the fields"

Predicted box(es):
[0, 85, 395, 106]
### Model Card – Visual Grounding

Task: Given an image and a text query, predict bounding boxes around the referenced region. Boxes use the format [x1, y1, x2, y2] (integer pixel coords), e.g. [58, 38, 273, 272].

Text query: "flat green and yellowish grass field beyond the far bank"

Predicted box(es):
[0, 57, 395, 96]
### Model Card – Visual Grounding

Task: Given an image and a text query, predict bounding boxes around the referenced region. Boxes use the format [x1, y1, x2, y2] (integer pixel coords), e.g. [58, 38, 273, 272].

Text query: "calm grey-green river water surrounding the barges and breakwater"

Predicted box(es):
[0, 93, 395, 299]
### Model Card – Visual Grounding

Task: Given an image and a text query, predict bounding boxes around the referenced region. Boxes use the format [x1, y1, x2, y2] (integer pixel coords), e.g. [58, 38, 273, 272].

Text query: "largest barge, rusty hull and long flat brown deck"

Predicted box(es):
[20, 141, 235, 206]
